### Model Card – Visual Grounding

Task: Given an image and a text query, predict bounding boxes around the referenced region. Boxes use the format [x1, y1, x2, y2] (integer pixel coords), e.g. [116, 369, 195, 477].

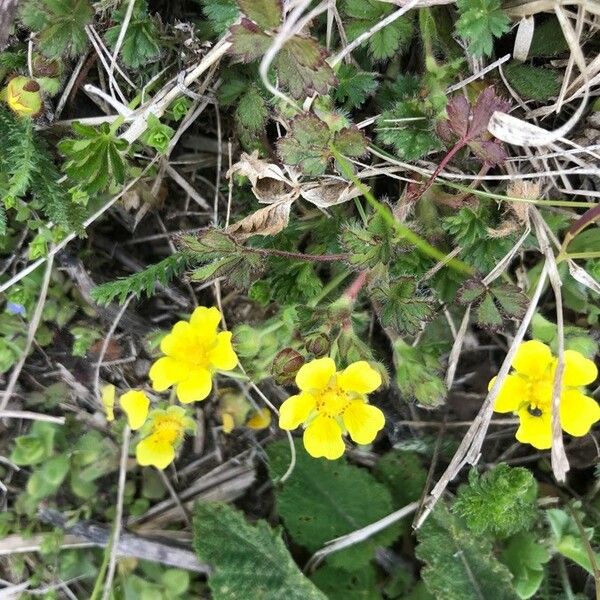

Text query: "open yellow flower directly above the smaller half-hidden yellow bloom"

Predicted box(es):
[149, 306, 238, 404]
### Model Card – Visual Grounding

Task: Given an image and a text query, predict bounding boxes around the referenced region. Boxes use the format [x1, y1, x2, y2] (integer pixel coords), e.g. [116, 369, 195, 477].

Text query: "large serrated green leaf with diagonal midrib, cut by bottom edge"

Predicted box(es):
[194, 502, 326, 600]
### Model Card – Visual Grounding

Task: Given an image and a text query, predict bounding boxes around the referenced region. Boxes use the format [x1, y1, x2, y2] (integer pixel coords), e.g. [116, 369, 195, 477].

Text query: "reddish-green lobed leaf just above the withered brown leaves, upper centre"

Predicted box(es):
[277, 113, 367, 176]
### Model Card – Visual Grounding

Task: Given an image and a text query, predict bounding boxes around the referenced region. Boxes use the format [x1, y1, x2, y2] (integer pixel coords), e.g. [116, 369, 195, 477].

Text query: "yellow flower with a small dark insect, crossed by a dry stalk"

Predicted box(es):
[489, 340, 600, 450]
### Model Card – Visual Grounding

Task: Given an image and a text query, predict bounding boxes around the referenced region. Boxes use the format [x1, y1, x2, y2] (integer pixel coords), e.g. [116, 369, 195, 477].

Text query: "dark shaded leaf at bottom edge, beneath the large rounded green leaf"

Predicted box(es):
[311, 564, 381, 600]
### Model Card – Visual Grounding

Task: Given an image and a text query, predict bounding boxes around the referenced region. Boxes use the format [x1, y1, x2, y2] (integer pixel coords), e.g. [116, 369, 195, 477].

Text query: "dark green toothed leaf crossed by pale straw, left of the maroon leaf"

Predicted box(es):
[377, 98, 441, 160]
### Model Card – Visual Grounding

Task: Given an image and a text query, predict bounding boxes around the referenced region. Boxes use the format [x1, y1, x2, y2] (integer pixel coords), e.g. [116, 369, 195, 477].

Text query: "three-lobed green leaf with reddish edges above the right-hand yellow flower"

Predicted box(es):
[457, 279, 529, 331]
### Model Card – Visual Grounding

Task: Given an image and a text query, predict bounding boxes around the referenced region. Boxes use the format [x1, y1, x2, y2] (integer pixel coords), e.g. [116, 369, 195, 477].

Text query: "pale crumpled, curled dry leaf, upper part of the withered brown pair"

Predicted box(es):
[227, 150, 300, 204]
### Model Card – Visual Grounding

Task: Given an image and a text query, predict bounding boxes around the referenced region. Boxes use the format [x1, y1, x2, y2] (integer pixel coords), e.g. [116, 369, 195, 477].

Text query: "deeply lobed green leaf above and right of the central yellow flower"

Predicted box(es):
[371, 276, 434, 335]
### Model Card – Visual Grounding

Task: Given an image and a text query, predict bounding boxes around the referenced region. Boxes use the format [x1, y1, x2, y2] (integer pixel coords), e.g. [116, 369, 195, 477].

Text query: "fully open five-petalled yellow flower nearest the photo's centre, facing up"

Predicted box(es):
[279, 357, 385, 460]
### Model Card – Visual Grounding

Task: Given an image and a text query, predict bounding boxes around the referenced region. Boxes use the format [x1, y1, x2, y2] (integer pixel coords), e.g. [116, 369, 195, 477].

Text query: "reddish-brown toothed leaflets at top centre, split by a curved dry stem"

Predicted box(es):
[229, 0, 336, 98]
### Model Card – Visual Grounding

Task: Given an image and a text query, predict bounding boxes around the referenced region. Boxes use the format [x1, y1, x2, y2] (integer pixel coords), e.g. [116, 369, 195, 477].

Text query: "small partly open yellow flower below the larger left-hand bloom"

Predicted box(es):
[135, 406, 195, 470]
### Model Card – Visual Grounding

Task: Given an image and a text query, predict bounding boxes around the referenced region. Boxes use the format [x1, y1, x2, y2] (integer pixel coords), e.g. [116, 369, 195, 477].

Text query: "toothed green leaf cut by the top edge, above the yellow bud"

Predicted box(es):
[20, 0, 94, 58]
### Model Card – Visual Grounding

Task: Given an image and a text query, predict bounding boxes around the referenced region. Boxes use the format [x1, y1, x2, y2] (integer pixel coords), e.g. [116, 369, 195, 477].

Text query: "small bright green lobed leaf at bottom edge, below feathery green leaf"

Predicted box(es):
[501, 531, 550, 600]
